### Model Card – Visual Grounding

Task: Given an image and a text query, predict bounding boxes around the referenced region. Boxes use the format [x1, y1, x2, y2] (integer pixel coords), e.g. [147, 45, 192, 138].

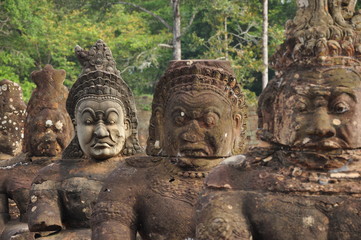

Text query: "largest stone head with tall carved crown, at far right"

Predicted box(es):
[258, 0, 361, 154]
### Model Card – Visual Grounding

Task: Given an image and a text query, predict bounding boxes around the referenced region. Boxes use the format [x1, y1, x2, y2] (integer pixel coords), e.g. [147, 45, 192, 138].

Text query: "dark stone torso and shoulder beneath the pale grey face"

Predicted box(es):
[28, 159, 124, 229]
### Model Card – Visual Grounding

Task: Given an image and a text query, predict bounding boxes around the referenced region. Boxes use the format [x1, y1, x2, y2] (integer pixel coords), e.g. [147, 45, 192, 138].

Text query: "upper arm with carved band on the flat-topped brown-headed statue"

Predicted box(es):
[91, 165, 142, 240]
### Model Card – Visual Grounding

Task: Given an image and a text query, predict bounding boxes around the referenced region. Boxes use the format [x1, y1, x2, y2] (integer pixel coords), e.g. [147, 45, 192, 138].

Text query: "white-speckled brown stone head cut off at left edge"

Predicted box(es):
[0, 79, 26, 156]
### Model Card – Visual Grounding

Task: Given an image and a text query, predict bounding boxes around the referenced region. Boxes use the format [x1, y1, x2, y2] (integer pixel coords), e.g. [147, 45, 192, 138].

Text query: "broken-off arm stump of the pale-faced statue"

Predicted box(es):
[27, 177, 63, 236]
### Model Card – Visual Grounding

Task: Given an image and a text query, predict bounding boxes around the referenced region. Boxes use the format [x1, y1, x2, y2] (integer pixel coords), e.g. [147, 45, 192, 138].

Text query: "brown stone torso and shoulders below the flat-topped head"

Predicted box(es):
[94, 157, 210, 240]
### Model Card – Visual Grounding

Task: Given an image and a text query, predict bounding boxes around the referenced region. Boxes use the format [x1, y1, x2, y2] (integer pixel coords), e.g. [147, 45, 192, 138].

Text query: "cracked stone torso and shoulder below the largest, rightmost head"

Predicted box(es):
[197, 150, 361, 240]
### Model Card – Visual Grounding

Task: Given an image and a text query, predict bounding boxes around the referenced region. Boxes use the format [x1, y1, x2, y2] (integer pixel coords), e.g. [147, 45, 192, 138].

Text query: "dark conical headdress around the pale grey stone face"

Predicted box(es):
[63, 40, 141, 158]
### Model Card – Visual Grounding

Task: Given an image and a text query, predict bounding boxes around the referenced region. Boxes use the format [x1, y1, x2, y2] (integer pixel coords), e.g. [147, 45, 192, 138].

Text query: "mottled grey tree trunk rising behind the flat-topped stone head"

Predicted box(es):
[172, 0, 182, 60]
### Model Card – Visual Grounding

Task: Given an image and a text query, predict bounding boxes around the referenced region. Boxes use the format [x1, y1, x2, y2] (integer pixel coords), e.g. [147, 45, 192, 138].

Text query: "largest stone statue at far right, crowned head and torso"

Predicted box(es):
[197, 0, 361, 240]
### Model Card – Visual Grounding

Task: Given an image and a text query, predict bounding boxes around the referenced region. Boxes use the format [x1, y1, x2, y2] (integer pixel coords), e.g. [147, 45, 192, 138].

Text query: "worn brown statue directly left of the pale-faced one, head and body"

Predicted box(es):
[0, 65, 74, 239]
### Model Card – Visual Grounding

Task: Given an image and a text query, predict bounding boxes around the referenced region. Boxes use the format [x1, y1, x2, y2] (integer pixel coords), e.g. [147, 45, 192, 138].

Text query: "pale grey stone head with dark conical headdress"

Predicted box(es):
[63, 40, 141, 160]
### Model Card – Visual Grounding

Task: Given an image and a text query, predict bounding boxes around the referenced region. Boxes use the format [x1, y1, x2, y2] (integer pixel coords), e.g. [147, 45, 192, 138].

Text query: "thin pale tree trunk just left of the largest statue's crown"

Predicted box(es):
[262, 0, 268, 89]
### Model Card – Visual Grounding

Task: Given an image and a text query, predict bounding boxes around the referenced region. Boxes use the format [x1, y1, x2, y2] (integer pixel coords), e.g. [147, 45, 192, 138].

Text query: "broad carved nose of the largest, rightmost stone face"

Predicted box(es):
[307, 108, 336, 138]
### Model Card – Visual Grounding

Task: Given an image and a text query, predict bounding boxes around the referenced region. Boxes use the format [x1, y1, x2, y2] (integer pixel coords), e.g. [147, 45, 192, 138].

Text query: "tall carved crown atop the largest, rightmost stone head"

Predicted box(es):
[270, 0, 361, 70]
